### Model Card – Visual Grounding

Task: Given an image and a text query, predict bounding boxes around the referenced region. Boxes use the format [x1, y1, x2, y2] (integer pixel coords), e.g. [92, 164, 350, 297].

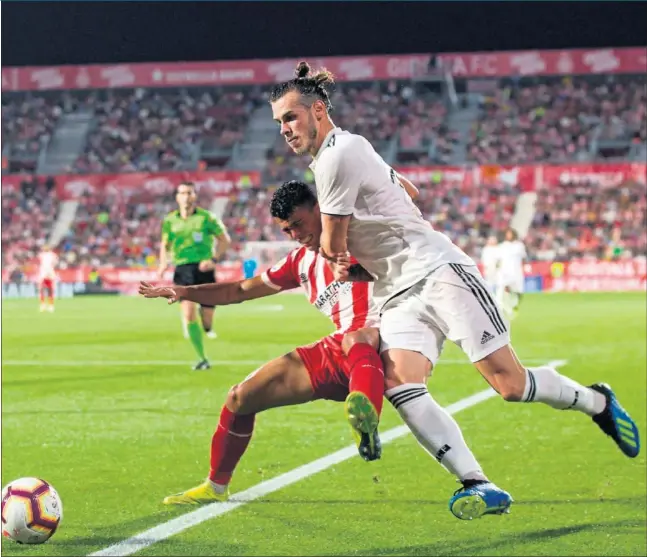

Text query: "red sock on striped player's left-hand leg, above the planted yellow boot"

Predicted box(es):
[209, 406, 256, 485]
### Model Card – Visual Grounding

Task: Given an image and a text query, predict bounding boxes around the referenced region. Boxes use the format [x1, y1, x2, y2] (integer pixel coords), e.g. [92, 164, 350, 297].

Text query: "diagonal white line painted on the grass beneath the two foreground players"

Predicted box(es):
[89, 360, 567, 557]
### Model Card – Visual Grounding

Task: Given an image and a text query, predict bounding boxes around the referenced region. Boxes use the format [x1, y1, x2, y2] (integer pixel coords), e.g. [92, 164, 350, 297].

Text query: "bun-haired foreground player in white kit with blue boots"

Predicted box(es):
[270, 62, 640, 519]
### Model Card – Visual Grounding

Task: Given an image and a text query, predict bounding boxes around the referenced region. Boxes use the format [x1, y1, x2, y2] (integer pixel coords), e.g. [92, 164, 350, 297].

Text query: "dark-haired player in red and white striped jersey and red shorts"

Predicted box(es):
[139, 181, 384, 505]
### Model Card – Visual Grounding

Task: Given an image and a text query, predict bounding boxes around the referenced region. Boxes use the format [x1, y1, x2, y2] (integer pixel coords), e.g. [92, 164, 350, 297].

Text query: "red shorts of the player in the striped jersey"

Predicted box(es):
[296, 336, 350, 402]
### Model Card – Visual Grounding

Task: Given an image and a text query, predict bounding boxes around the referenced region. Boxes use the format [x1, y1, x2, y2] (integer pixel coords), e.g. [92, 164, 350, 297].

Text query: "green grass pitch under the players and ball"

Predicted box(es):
[2, 293, 647, 556]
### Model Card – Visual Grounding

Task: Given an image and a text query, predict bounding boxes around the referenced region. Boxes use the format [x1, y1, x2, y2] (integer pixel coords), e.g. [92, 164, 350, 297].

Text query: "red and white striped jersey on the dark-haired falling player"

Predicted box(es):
[261, 247, 379, 333]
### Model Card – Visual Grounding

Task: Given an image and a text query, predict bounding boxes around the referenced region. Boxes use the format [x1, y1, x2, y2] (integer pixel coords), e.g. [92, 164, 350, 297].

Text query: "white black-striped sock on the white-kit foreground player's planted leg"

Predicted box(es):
[385, 383, 487, 480]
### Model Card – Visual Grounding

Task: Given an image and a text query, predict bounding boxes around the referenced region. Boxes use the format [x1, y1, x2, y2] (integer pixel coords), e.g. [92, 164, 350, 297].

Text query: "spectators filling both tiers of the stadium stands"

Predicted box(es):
[2, 73, 647, 274]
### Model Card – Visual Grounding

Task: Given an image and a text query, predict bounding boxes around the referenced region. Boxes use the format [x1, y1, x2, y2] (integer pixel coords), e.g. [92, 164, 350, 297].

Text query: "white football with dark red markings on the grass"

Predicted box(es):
[2, 478, 63, 544]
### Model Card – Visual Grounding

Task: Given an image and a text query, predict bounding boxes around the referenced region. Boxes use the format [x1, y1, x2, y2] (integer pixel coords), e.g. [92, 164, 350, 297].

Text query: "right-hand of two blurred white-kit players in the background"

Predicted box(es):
[496, 228, 528, 317]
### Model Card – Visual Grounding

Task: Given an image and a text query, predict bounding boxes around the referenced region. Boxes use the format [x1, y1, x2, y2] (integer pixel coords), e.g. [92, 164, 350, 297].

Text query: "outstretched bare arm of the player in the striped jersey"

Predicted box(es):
[139, 277, 278, 306]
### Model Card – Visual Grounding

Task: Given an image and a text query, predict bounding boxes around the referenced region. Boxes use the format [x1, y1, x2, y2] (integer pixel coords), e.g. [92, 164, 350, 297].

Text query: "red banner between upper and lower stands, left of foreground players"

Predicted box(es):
[2, 170, 261, 201]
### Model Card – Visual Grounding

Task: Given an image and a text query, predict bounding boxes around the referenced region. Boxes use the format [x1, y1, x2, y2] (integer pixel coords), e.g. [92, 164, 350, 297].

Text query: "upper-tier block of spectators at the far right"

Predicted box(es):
[468, 78, 647, 164]
